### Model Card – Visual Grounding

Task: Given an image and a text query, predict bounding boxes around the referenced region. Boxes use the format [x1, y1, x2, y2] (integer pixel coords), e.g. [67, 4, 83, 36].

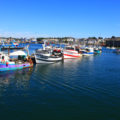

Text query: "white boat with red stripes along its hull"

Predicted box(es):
[63, 46, 82, 59]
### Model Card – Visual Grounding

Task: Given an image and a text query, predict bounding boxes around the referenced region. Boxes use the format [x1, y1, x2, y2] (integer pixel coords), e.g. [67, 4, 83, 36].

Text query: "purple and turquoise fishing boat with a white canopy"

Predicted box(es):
[0, 51, 33, 71]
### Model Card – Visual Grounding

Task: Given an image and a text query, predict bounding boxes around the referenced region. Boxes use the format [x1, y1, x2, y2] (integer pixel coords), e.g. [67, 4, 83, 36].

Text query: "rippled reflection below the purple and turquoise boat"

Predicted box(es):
[0, 68, 33, 94]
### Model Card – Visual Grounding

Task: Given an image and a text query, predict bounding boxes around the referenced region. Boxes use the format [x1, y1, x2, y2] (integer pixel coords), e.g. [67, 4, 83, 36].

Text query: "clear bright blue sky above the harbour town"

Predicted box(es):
[0, 0, 120, 38]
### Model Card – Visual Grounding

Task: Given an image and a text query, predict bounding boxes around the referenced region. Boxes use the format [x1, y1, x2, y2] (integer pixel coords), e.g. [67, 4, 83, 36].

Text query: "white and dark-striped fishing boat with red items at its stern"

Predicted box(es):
[35, 43, 63, 63]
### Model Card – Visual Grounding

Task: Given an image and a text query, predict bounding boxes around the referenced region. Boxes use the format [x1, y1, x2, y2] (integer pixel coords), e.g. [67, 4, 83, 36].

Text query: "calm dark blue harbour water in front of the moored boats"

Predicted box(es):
[0, 47, 120, 120]
